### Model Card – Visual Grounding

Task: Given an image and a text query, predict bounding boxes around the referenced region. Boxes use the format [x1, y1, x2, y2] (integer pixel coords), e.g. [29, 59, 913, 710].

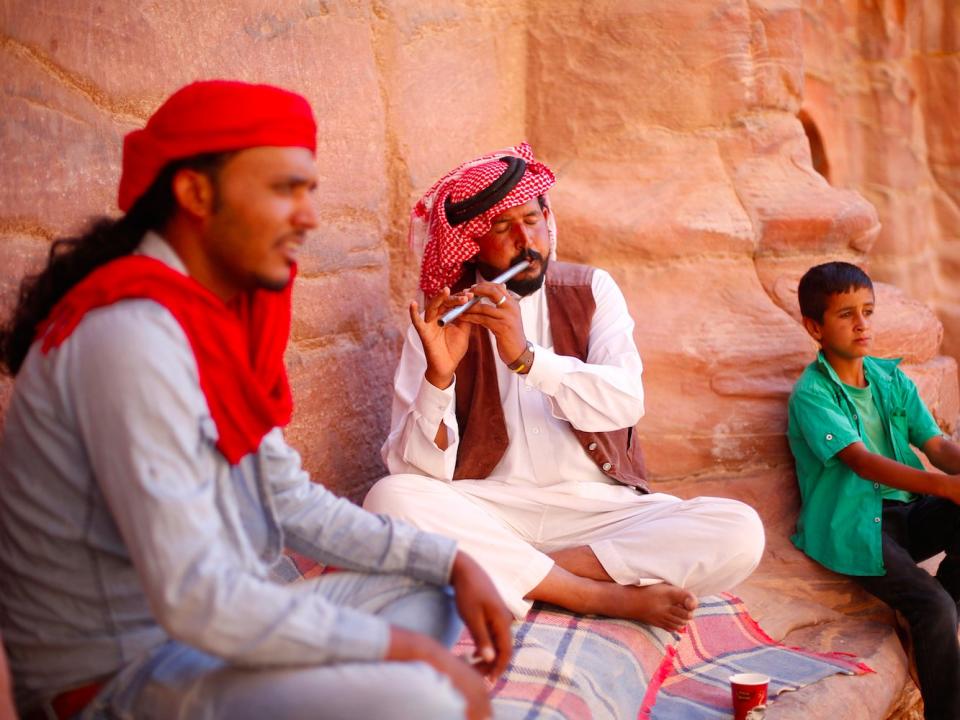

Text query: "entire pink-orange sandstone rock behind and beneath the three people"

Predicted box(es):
[0, 0, 960, 719]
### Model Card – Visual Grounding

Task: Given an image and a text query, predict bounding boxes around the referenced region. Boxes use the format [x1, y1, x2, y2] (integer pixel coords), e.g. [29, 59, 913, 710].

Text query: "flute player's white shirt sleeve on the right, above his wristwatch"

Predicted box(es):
[526, 269, 644, 432]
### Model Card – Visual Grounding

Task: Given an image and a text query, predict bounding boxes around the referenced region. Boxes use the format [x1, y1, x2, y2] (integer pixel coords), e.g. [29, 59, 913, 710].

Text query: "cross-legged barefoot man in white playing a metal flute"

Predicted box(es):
[364, 144, 764, 630]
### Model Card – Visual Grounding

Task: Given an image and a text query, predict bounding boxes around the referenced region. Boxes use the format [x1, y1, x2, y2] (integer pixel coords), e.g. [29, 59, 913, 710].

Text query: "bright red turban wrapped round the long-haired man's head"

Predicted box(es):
[117, 80, 317, 212]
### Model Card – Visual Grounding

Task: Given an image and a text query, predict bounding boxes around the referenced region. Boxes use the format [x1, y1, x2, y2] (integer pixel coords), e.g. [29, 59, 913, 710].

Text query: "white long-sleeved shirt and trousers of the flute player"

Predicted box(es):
[364, 269, 763, 617]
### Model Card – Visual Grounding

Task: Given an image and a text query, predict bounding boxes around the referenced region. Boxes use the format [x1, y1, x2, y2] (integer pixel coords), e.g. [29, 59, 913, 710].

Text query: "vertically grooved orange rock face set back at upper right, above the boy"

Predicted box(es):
[801, 0, 960, 358]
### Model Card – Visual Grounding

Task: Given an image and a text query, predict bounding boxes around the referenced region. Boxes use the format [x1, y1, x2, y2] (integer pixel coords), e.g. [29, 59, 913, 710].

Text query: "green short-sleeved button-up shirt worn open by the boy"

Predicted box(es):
[787, 353, 940, 575]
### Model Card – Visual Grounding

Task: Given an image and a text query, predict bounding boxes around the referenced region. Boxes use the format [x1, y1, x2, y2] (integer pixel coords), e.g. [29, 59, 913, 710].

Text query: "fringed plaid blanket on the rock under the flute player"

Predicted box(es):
[455, 593, 872, 720]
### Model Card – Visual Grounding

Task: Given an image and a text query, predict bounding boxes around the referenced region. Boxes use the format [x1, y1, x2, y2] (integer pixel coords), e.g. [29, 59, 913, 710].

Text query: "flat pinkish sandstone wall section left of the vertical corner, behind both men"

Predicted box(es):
[0, 0, 526, 499]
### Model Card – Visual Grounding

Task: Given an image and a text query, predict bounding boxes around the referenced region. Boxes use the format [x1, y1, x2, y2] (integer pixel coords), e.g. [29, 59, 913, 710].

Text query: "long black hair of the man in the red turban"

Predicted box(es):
[0, 153, 232, 376]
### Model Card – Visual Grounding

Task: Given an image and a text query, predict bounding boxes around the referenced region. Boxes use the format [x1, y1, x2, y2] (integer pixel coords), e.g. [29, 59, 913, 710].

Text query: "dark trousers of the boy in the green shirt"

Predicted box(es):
[853, 496, 960, 720]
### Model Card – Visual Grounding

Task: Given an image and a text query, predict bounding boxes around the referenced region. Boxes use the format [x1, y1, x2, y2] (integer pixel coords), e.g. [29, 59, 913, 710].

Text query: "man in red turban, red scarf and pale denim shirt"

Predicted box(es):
[0, 81, 511, 720]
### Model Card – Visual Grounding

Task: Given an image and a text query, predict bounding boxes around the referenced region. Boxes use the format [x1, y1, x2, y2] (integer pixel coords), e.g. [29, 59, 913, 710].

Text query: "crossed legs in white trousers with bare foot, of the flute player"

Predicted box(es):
[364, 475, 763, 629]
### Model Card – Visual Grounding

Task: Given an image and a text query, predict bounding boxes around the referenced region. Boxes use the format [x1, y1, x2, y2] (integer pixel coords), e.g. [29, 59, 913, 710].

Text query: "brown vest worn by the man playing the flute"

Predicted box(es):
[453, 261, 650, 492]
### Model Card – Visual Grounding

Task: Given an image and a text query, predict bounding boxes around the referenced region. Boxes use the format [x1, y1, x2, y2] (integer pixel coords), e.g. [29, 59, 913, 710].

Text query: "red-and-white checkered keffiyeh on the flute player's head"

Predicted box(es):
[408, 143, 557, 297]
